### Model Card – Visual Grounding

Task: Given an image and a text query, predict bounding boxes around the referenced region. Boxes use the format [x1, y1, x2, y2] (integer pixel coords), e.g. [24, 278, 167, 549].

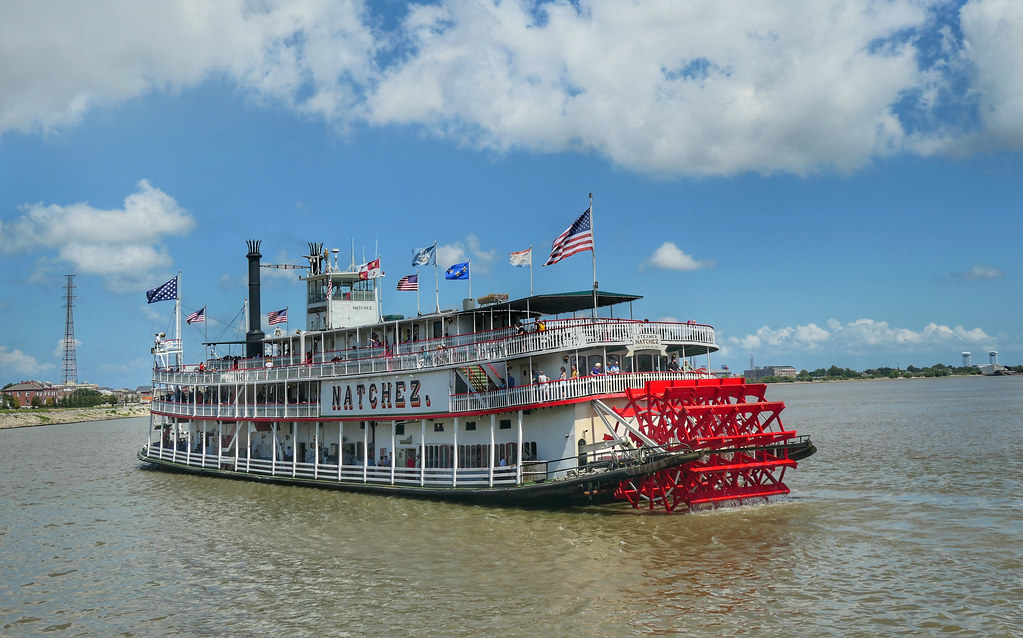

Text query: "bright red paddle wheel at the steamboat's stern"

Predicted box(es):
[615, 378, 801, 511]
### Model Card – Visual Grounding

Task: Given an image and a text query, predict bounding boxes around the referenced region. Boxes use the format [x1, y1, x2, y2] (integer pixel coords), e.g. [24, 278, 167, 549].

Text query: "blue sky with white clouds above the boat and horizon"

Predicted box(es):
[0, 0, 1023, 388]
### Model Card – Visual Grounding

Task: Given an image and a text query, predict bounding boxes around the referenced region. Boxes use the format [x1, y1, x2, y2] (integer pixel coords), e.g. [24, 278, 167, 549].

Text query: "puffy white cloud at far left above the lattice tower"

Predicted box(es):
[0, 180, 195, 291]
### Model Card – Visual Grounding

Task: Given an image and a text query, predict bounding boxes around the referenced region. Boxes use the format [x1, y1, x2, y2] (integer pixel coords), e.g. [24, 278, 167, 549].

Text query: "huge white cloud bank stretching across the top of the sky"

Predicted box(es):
[0, 0, 1023, 175]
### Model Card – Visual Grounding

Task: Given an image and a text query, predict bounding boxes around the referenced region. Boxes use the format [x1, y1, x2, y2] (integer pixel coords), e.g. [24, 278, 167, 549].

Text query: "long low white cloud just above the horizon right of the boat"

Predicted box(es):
[727, 319, 992, 354]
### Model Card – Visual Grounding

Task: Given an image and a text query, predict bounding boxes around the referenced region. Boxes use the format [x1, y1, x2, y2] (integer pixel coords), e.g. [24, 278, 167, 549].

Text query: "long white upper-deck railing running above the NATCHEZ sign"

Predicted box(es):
[153, 319, 715, 385]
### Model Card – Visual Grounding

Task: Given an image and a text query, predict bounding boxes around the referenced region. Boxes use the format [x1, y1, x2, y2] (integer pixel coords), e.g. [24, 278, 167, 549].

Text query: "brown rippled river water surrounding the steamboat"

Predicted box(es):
[0, 376, 1023, 636]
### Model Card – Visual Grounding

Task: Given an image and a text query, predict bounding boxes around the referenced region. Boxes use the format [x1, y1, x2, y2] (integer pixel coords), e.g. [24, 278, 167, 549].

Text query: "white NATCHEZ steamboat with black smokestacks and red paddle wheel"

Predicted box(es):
[138, 240, 815, 511]
